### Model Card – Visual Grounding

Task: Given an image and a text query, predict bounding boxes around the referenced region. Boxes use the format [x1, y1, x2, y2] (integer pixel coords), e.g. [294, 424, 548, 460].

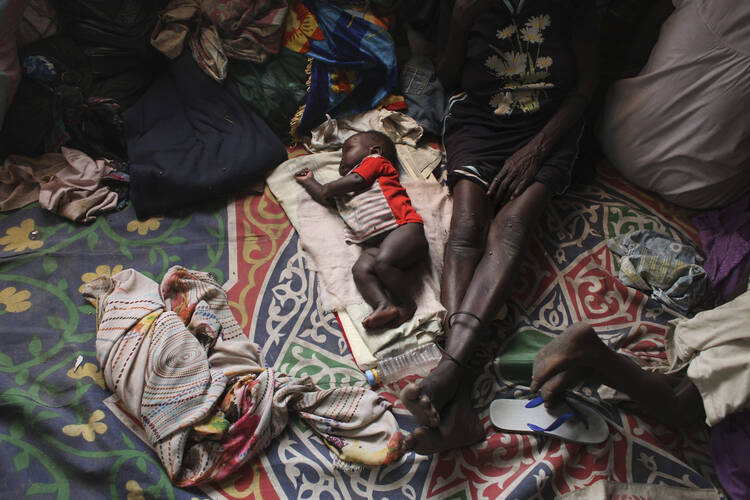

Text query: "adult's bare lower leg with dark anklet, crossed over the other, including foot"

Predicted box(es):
[401, 182, 550, 433]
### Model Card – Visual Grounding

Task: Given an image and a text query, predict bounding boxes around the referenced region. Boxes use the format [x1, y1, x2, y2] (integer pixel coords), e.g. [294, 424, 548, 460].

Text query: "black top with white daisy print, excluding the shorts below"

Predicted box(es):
[461, 0, 598, 119]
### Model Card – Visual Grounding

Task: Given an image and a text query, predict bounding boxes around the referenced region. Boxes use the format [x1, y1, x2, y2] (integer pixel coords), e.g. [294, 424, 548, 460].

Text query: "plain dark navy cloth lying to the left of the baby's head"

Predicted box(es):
[125, 52, 286, 218]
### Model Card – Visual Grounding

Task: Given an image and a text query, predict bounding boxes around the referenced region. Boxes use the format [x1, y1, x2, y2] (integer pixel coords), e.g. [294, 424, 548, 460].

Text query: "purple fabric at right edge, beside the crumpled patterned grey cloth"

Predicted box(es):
[693, 193, 750, 305]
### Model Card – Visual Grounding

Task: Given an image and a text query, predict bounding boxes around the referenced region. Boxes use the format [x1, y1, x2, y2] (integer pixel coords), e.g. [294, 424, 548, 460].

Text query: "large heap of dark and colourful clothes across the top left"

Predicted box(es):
[0, 0, 443, 222]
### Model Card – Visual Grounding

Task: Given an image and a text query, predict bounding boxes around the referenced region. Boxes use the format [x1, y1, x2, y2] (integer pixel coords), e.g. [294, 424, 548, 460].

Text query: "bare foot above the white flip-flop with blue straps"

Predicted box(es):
[531, 323, 613, 402]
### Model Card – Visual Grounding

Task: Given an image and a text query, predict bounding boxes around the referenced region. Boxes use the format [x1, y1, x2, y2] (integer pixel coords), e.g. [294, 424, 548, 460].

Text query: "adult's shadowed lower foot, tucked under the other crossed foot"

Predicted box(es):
[404, 391, 485, 455]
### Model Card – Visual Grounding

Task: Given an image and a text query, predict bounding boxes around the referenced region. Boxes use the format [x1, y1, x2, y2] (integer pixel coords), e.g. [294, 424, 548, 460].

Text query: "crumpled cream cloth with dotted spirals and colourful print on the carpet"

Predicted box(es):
[84, 267, 402, 486]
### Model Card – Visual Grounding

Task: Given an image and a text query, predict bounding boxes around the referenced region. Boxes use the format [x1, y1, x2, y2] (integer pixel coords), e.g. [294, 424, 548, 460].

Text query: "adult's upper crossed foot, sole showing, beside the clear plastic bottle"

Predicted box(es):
[400, 358, 461, 427]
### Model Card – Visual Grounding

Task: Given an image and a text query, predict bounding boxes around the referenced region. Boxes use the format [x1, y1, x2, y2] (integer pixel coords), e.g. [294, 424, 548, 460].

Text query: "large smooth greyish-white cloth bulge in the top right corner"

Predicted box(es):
[598, 0, 750, 209]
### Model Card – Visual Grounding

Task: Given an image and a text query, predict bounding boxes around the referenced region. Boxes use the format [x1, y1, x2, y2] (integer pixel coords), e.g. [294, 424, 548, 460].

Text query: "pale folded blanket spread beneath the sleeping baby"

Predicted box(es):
[268, 151, 452, 368]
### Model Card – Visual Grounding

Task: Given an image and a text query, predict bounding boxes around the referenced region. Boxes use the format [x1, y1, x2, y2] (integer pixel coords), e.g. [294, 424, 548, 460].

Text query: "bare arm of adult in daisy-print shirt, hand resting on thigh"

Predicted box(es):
[487, 19, 599, 204]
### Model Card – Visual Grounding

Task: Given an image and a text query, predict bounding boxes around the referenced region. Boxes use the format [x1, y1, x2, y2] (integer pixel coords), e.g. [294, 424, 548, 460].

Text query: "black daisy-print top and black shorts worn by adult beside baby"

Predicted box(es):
[443, 0, 598, 194]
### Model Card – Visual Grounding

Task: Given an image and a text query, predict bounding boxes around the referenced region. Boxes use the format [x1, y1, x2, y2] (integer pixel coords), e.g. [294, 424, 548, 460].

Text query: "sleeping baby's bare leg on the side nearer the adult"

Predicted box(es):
[374, 223, 428, 326]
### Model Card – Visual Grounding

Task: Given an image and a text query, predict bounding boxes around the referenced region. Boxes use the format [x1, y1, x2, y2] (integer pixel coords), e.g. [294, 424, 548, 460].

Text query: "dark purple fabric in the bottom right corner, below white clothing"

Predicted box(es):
[711, 411, 750, 500]
